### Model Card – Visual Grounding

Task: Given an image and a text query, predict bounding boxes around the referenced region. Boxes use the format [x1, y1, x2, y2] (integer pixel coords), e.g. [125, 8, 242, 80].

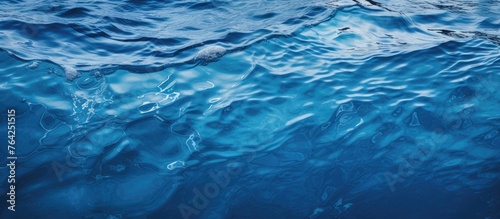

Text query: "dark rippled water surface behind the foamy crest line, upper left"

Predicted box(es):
[0, 1, 335, 71]
